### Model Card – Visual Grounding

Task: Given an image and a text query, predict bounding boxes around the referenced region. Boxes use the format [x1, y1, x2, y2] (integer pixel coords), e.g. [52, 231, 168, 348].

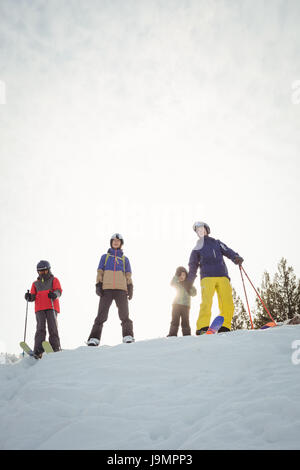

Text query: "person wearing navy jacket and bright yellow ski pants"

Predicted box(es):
[185, 222, 244, 335]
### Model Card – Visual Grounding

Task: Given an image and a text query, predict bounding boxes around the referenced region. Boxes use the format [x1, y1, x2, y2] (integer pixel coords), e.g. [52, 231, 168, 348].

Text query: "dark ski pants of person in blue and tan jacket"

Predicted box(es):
[89, 289, 133, 340]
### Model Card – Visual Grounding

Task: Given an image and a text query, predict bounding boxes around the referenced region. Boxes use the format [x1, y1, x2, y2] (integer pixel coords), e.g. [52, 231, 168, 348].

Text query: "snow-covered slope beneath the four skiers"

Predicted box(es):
[0, 326, 300, 450]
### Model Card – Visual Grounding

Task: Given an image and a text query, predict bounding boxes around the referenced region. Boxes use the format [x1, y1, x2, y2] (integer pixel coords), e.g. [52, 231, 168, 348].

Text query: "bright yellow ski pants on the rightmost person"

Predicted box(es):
[197, 277, 234, 330]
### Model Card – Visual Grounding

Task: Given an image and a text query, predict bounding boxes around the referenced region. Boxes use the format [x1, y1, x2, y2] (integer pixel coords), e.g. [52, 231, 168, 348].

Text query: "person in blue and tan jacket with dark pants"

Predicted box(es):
[87, 233, 134, 346]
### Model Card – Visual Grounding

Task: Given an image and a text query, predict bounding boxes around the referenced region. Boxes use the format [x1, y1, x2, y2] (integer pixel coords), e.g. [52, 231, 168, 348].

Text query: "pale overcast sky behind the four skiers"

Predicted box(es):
[0, 0, 300, 352]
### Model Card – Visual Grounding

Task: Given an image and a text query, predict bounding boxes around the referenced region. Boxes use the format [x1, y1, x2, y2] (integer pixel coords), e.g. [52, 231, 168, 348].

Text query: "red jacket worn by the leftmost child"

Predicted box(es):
[30, 275, 62, 313]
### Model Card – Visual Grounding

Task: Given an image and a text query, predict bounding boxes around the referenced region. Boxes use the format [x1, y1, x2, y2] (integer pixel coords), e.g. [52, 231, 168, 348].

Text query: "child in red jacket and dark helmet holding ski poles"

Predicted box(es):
[25, 260, 62, 357]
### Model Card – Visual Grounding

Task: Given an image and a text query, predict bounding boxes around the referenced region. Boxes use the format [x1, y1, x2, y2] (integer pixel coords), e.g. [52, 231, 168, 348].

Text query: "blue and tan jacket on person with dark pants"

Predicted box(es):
[96, 248, 132, 291]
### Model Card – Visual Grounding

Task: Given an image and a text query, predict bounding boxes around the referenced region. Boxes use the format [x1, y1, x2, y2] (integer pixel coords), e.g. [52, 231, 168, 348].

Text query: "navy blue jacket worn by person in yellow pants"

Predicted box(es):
[187, 235, 239, 282]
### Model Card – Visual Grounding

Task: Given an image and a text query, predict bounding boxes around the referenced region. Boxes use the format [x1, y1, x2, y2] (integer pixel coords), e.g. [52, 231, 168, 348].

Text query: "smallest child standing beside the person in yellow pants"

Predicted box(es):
[168, 266, 197, 336]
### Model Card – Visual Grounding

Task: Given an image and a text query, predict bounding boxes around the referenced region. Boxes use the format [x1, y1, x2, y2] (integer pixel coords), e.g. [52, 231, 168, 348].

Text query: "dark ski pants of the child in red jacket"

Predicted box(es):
[34, 309, 60, 354]
